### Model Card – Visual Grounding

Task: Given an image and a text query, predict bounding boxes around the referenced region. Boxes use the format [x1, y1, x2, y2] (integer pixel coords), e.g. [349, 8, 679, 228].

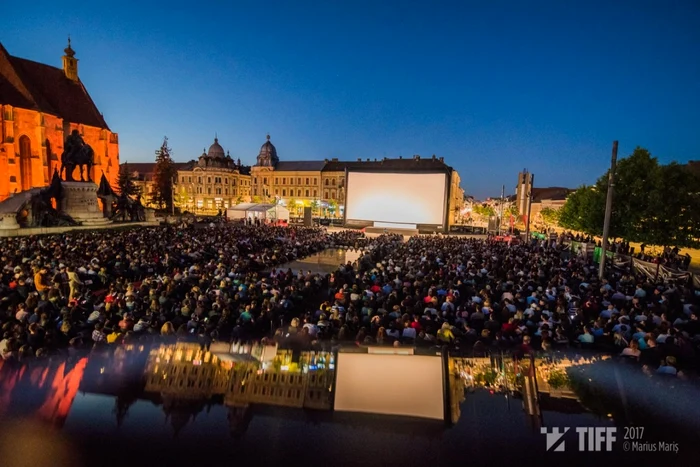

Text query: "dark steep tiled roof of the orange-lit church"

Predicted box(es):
[0, 44, 109, 129]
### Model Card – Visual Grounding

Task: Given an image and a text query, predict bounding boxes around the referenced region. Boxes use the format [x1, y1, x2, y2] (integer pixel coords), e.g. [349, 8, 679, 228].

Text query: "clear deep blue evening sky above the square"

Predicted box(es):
[0, 0, 700, 198]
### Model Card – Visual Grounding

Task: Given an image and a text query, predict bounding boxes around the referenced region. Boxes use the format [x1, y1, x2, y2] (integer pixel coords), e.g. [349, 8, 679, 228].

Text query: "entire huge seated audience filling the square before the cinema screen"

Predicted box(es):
[0, 223, 700, 374]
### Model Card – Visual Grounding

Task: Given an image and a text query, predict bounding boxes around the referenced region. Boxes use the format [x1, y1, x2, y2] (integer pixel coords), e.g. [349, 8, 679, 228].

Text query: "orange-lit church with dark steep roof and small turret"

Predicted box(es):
[0, 39, 119, 201]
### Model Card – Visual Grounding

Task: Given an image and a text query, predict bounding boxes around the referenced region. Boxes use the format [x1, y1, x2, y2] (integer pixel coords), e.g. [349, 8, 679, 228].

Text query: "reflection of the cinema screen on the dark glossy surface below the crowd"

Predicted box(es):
[334, 352, 445, 420]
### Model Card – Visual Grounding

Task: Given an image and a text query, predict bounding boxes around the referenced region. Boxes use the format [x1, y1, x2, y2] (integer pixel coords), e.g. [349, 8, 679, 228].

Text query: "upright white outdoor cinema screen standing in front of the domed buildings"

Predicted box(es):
[345, 171, 447, 225]
